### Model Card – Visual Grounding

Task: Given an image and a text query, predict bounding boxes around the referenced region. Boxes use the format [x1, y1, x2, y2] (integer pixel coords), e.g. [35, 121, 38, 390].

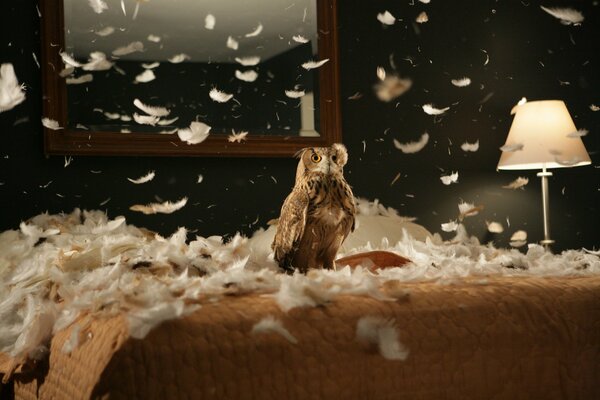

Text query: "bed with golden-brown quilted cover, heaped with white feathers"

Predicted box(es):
[0, 202, 600, 399]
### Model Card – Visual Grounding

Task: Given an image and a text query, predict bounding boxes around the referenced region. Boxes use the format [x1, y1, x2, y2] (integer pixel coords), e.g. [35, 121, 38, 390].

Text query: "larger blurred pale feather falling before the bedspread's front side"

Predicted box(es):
[356, 316, 409, 361]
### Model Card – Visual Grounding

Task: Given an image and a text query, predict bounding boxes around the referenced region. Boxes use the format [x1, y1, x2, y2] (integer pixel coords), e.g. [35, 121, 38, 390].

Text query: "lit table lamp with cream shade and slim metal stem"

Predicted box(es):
[498, 100, 592, 247]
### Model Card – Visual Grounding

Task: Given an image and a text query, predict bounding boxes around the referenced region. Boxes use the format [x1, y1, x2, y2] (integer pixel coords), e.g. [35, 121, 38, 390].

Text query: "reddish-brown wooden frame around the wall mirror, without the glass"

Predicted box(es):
[40, 0, 342, 157]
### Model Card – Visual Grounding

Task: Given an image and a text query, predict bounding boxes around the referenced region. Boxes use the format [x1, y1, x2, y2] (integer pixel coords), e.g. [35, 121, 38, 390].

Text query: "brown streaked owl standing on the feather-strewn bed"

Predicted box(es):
[271, 143, 356, 272]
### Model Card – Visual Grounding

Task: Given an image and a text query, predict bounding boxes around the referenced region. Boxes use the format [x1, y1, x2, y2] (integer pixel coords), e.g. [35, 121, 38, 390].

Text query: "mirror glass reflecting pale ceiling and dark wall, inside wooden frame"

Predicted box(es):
[61, 0, 320, 136]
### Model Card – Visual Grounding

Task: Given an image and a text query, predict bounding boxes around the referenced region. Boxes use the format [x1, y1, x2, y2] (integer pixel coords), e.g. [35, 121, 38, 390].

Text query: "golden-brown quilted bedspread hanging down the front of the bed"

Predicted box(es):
[0, 276, 600, 400]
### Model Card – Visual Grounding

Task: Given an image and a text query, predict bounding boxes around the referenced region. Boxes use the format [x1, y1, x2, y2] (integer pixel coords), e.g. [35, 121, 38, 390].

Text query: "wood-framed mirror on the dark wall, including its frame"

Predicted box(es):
[41, 0, 341, 156]
